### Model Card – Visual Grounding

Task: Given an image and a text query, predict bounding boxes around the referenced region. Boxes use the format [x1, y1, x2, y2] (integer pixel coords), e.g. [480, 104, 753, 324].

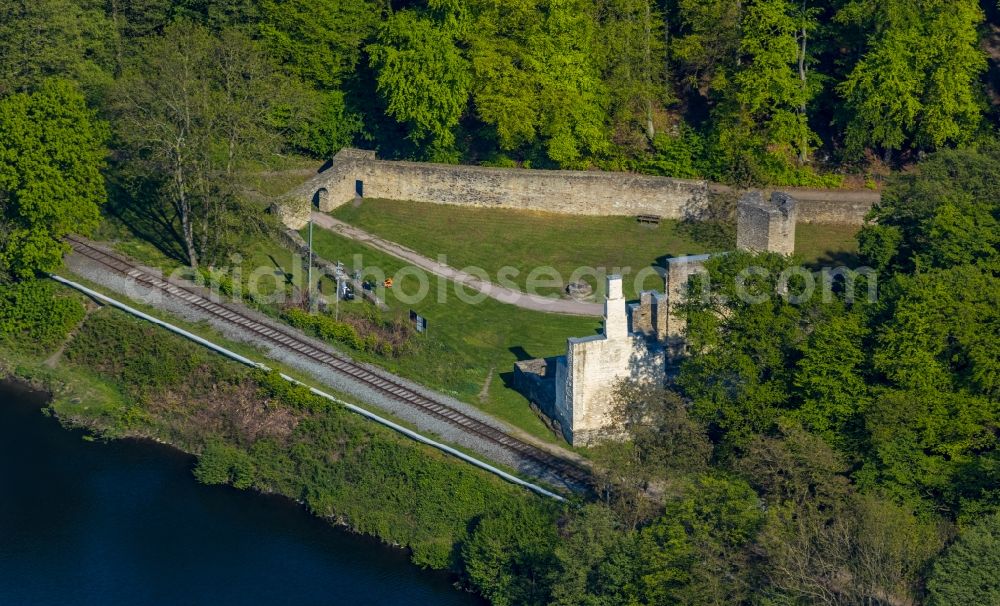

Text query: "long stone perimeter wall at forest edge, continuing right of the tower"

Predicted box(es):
[281, 148, 879, 225]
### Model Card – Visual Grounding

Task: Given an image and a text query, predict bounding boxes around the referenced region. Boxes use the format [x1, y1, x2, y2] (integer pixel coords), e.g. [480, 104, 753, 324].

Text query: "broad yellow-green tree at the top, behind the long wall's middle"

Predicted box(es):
[468, 0, 609, 168]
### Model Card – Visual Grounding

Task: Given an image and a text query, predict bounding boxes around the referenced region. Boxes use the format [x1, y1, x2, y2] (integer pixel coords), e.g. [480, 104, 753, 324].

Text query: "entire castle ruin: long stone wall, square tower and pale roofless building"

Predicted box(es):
[266, 148, 836, 445]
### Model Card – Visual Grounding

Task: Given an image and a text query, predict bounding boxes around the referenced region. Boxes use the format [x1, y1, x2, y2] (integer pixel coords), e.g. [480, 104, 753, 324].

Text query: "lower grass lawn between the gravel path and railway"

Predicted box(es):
[313, 229, 601, 440]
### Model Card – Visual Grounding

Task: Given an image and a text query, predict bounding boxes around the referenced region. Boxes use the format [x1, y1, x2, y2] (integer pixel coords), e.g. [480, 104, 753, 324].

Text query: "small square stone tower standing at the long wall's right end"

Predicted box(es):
[736, 191, 797, 255]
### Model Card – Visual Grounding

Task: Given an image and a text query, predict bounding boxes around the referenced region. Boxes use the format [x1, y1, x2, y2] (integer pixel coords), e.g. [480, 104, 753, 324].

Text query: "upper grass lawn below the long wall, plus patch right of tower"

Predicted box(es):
[332, 199, 857, 298]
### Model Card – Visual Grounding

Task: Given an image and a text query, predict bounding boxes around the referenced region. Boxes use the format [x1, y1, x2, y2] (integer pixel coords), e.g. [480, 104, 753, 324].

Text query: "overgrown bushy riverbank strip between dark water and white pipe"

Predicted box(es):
[0, 281, 561, 585]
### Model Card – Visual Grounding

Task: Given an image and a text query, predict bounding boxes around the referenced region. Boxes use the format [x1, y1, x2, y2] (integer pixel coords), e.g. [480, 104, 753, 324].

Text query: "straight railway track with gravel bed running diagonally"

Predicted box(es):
[67, 236, 590, 490]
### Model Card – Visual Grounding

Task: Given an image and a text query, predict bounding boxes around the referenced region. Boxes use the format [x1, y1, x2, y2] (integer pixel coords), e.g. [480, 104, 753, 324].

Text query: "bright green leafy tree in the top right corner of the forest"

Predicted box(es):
[838, 0, 986, 158]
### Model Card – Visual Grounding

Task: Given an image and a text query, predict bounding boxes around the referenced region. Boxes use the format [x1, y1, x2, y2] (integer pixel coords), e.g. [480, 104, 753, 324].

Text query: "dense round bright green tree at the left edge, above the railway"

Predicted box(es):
[0, 80, 108, 278]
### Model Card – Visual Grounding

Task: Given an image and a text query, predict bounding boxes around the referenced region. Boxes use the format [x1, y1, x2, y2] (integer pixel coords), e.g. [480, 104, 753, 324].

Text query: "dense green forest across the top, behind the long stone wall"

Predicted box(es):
[0, 0, 1000, 270]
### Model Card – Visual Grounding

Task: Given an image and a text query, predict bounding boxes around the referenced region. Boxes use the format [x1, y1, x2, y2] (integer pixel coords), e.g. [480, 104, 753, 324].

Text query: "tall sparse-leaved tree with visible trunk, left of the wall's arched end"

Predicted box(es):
[114, 22, 287, 267]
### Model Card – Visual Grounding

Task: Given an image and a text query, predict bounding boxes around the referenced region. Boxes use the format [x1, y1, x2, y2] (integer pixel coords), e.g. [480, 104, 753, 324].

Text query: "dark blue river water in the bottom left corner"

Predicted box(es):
[0, 383, 481, 606]
